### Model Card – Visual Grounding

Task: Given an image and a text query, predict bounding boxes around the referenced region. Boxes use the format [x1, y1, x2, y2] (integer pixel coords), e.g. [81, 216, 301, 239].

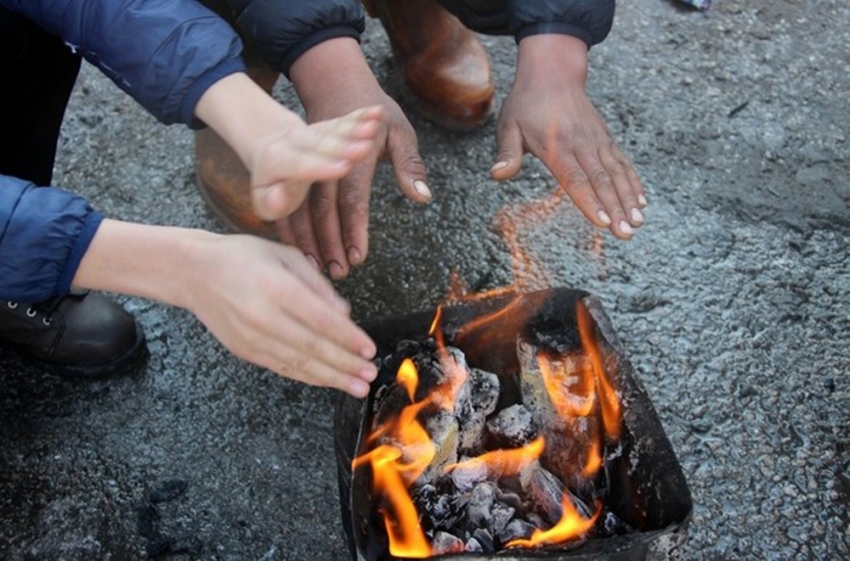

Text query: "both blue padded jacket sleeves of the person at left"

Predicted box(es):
[0, 0, 244, 303]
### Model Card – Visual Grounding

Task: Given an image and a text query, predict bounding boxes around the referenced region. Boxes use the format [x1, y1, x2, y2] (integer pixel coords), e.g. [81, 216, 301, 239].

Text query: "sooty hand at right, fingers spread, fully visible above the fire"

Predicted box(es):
[491, 34, 646, 239]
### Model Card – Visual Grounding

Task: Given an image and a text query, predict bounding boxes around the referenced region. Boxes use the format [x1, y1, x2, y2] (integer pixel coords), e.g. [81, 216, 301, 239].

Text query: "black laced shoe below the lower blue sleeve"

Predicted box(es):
[0, 292, 146, 378]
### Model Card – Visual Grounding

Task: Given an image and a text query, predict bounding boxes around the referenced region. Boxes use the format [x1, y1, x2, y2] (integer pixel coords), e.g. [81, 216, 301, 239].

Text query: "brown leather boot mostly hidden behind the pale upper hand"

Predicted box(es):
[195, 67, 279, 239]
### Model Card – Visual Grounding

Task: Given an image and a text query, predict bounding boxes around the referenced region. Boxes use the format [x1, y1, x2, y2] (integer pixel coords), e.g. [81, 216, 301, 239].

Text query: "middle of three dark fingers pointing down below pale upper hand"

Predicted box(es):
[309, 181, 349, 280]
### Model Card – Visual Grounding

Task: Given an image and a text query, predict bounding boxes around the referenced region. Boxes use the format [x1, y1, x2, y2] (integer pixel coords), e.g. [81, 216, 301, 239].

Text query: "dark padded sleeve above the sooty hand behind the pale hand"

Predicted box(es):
[207, 0, 365, 75]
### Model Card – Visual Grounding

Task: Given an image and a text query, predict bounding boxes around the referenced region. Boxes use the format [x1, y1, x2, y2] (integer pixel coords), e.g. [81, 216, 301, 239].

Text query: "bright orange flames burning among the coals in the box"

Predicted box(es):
[352, 299, 622, 558]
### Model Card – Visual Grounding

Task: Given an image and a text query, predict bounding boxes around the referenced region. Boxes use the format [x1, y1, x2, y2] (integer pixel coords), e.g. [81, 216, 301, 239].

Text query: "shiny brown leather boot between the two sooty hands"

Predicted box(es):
[363, 0, 493, 130]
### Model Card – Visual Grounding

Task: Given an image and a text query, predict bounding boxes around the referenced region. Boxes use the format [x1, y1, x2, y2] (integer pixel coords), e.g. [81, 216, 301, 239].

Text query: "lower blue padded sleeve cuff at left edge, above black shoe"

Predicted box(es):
[0, 175, 103, 303]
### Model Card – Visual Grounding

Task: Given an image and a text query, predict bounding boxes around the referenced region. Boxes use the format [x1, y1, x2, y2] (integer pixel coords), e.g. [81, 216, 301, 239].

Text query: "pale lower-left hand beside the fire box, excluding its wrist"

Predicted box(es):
[184, 235, 377, 398]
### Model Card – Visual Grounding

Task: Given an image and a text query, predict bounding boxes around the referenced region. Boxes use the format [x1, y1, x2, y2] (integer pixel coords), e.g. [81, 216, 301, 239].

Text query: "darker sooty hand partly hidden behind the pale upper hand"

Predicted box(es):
[277, 38, 431, 279]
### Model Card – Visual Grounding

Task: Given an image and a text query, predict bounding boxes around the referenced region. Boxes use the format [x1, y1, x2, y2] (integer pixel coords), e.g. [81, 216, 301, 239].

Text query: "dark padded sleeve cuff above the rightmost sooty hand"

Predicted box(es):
[439, 0, 615, 47]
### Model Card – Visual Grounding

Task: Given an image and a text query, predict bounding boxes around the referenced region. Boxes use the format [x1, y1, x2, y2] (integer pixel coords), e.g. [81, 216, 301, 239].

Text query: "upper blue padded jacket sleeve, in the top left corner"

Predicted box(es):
[0, 0, 244, 124]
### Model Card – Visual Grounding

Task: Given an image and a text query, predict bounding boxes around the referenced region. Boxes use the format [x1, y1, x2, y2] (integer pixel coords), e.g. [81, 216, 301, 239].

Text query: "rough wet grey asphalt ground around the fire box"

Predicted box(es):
[0, 0, 850, 560]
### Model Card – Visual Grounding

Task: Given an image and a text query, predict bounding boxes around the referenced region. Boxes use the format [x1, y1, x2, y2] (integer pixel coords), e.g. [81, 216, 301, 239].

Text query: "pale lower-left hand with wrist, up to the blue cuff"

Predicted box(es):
[74, 220, 377, 397]
